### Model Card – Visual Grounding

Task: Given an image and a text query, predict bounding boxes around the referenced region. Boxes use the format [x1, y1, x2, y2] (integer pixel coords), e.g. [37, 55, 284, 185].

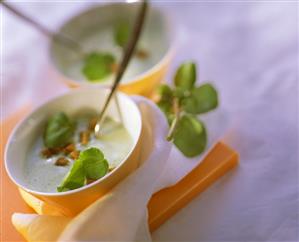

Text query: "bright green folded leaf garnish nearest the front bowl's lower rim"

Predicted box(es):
[57, 148, 109, 192]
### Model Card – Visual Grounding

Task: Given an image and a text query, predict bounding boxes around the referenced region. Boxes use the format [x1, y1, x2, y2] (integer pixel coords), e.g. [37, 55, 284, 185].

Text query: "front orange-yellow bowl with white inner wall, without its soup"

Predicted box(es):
[5, 88, 142, 216]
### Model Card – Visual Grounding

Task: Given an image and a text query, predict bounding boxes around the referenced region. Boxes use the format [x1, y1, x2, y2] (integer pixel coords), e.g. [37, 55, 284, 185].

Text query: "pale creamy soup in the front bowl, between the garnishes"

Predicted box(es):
[24, 117, 133, 192]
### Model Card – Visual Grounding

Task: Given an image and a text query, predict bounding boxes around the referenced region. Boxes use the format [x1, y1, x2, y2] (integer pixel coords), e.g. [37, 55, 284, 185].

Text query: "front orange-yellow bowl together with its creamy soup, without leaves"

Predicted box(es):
[5, 88, 142, 215]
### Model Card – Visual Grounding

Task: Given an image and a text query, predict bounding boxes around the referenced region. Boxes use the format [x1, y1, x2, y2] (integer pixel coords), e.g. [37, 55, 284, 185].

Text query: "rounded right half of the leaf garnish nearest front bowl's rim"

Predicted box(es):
[79, 148, 109, 180]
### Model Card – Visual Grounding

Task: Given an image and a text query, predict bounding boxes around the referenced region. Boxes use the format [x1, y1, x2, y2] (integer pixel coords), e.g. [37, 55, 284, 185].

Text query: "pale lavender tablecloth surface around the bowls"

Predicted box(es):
[1, 1, 299, 241]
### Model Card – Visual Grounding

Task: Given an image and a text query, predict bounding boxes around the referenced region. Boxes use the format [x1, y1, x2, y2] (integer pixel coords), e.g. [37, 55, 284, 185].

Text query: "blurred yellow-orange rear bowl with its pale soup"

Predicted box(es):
[50, 2, 175, 96]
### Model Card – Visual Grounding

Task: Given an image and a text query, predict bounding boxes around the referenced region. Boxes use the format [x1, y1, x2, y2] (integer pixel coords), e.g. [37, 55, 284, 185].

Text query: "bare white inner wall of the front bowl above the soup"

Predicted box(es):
[5, 89, 142, 190]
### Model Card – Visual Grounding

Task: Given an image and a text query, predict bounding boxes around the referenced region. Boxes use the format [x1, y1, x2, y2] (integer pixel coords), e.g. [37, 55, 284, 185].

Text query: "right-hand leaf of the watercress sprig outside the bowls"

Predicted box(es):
[182, 83, 218, 114]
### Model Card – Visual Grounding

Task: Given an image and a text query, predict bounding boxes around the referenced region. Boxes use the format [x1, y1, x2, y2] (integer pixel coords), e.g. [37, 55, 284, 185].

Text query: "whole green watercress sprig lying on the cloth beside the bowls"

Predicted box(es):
[157, 62, 218, 157]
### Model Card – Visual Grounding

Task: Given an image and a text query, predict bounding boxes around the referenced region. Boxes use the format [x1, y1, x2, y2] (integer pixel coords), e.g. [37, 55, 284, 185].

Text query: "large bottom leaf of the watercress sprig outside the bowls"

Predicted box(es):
[173, 115, 207, 157]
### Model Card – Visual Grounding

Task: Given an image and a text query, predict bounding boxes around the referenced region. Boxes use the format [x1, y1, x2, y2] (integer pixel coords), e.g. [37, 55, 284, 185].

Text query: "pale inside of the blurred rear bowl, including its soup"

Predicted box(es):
[50, 3, 172, 85]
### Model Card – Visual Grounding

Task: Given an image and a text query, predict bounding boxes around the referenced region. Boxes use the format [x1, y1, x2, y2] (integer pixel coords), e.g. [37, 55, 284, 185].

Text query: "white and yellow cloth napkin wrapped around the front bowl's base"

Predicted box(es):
[12, 96, 171, 241]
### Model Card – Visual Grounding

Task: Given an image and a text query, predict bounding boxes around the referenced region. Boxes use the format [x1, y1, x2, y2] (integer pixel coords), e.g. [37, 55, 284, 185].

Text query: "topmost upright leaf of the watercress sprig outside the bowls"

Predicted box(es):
[174, 62, 196, 90]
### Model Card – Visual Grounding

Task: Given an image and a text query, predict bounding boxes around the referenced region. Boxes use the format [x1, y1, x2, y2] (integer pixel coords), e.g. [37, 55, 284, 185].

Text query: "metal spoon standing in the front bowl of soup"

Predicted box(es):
[94, 0, 148, 137]
